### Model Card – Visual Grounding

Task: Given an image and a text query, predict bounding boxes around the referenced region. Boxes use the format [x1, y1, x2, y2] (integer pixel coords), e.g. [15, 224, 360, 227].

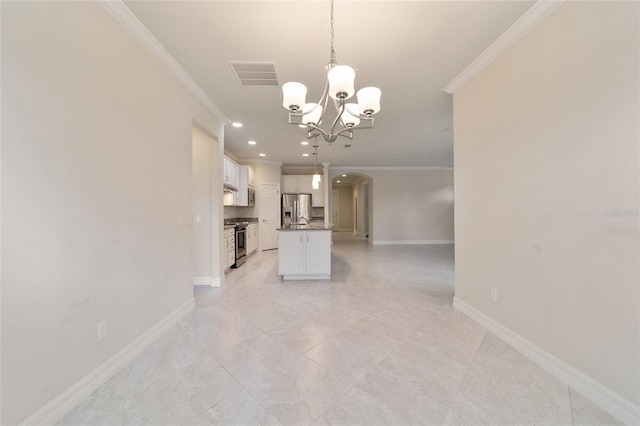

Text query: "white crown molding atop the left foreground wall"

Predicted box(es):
[98, 0, 231, 124]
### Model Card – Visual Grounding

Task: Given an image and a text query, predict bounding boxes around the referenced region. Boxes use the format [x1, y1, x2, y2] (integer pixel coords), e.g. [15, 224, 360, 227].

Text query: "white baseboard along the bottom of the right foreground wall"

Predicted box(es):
[453, 297, 640, 425]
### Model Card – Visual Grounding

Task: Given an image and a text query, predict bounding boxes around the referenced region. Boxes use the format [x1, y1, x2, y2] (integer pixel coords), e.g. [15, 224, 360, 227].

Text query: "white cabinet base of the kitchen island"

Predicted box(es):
[278, 229, 331, 280]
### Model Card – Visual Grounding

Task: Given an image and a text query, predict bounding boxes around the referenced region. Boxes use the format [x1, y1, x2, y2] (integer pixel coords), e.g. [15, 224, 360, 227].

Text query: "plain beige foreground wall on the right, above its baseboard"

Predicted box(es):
[454, 1, 640, 406]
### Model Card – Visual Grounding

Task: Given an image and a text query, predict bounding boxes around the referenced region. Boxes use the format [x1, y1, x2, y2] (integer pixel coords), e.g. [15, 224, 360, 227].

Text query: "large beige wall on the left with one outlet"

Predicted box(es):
[0, 2, 223, 424]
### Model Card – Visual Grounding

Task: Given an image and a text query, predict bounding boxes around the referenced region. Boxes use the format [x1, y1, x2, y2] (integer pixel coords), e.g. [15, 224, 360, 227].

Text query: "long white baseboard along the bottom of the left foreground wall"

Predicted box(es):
[21, 298, 195, 425]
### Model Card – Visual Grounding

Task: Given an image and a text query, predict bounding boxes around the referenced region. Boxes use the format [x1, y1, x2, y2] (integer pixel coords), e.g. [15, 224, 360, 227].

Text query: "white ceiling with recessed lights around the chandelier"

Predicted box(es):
[125, 0, 535, 167]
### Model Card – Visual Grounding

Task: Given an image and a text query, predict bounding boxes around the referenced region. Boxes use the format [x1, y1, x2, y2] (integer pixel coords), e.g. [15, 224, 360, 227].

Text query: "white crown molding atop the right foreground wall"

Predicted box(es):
[442, 0, 564, 95]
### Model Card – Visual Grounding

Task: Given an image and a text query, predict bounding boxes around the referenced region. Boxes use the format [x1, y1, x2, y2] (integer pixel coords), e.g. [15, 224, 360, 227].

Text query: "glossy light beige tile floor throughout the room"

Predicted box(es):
[59, 237, 618, 426]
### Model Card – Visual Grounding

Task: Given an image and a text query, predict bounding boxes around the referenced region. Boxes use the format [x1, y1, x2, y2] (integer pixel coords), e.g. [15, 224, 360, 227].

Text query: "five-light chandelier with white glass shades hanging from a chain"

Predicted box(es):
[282, 0, 382, 143]
